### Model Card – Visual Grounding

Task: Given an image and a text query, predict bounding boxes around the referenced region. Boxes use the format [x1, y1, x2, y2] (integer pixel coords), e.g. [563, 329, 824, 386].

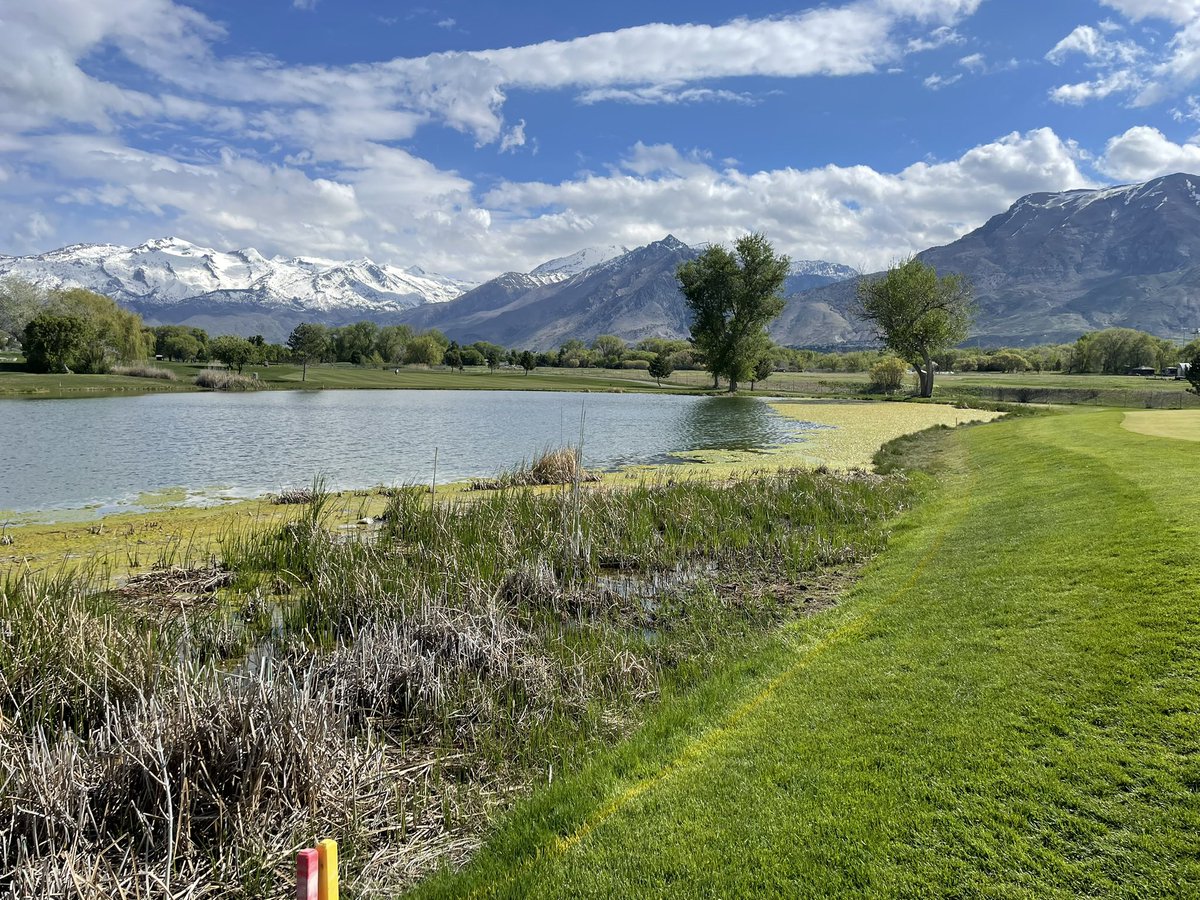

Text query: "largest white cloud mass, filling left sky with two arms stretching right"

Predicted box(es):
[0, 0, 1128, 277]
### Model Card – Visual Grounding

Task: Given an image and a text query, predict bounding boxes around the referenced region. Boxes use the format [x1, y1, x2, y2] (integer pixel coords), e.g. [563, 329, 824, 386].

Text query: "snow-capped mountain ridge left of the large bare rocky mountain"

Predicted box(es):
[0, 235, 857, 349]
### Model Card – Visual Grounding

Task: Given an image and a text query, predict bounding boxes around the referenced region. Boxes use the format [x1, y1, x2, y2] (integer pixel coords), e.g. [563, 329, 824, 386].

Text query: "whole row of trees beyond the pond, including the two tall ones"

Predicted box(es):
[11, 254, 1200, 396]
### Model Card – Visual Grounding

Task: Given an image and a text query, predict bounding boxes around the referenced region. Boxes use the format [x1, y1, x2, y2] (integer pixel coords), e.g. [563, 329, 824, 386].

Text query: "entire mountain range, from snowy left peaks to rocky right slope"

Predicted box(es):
[7, 174, 1200, 349]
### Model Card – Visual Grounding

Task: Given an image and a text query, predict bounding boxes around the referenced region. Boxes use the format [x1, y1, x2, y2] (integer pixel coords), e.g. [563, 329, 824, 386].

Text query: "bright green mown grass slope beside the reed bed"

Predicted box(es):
[415, 410, 1200, 898]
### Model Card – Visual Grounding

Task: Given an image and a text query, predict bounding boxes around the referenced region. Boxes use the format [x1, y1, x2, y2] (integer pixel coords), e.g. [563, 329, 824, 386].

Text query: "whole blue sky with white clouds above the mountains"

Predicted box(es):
[0, 0, 1200, 280]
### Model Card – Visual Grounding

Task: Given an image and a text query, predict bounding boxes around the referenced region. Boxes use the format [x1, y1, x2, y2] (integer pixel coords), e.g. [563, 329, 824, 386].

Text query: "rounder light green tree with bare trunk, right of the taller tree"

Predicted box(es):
[857, 258, 974, 397]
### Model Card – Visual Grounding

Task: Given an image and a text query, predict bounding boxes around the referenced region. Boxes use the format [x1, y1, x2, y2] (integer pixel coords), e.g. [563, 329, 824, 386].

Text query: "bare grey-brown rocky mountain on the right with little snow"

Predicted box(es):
[774, 174, 1200, 346]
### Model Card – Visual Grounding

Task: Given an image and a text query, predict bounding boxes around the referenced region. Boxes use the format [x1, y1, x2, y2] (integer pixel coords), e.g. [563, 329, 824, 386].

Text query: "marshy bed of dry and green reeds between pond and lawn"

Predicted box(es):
[0, 454, 912, 898]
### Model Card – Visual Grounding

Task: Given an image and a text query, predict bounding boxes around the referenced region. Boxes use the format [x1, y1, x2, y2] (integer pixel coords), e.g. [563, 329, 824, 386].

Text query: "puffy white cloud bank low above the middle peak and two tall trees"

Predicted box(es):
[484, 128, 1092, 273]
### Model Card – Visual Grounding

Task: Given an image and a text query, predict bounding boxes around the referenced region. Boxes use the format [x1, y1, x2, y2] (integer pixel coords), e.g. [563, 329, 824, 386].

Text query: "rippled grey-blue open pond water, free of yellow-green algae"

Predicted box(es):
[0, 390, 803, 514]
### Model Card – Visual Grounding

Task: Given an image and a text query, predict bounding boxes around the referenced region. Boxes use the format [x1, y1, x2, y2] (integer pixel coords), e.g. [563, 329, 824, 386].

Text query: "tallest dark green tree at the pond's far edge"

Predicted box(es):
[676, 234, 791, 392]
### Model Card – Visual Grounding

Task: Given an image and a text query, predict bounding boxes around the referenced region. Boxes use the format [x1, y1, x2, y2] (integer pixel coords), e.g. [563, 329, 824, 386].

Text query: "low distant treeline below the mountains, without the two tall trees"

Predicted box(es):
[0, 278, 1200, 376]
